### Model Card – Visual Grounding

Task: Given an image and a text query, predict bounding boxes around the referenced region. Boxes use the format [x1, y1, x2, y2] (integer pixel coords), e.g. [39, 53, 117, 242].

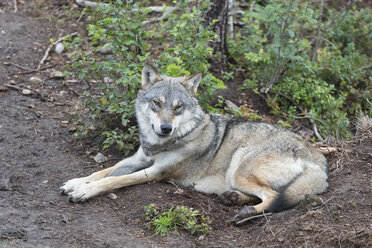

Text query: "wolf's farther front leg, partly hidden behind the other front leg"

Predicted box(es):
[60, 147, 152, 194]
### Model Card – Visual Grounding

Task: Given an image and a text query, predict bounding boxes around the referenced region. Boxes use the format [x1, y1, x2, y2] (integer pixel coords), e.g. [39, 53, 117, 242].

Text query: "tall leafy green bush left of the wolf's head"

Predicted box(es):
[68, 0, 150, 153]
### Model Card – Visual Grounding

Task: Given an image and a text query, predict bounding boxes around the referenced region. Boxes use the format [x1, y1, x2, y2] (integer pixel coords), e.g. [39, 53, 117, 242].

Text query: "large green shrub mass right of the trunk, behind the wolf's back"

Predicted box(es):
[230, 0, 372, 138]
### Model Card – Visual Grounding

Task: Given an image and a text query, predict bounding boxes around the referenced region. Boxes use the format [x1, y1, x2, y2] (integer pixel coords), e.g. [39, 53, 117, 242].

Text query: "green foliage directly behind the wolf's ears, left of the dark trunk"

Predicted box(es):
[156, 0, 225, 106]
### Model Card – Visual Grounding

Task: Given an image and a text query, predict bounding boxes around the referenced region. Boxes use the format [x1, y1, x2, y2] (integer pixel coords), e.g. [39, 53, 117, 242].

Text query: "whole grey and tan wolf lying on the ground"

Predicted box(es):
[61, 64, 328, 225]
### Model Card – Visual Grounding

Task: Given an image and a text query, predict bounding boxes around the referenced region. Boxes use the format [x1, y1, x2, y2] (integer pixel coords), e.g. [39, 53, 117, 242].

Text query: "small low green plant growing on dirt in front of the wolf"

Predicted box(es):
[144, 204, 211, 236]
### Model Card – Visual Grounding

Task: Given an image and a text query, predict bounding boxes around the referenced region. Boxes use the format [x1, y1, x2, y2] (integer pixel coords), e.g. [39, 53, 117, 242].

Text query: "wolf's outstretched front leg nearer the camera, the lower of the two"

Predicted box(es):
[68, 166, 162, 202]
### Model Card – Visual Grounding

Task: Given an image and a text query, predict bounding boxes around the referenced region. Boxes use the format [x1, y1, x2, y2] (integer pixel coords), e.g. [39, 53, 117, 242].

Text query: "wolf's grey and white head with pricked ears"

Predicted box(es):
[136, 64, 204, 143]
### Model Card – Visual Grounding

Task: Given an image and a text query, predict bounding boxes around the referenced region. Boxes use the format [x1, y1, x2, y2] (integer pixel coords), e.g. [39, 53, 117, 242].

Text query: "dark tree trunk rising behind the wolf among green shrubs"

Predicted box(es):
[203, 0, 229, 64]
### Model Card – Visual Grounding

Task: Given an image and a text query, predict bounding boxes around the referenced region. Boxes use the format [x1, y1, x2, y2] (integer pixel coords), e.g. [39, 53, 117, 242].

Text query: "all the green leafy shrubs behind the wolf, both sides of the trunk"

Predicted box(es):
[66, 0, 372, 153]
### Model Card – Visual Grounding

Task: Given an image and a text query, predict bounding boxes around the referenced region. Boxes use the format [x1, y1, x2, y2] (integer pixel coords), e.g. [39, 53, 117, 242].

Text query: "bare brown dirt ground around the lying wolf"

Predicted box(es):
[0, 0, 372, 247]
